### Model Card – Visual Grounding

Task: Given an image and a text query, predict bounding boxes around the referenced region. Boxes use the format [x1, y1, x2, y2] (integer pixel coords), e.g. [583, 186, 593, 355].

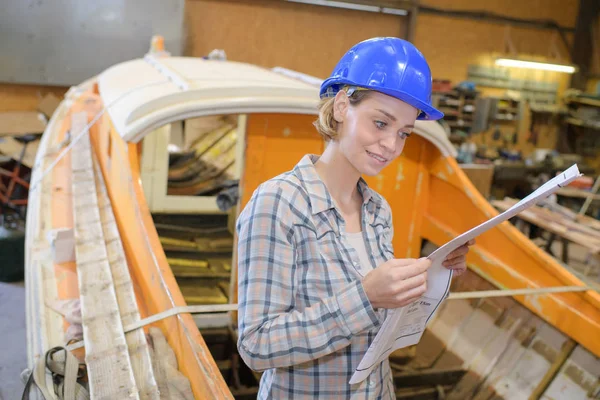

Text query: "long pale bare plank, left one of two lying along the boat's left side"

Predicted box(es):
[71, 112, 139, 399]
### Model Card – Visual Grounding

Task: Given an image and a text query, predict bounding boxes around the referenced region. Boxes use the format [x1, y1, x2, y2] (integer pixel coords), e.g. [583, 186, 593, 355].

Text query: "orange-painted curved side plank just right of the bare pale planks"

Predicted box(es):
[90, 115, 233, 399]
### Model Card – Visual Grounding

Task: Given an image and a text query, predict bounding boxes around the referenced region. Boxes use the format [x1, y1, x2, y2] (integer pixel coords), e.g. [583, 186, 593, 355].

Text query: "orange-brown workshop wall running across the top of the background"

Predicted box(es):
[0, 0, 578, 119]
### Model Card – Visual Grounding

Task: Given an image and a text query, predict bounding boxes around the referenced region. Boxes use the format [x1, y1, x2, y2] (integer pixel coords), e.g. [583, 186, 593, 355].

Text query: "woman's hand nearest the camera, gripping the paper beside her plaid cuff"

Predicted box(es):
[362, 258, 431, 308]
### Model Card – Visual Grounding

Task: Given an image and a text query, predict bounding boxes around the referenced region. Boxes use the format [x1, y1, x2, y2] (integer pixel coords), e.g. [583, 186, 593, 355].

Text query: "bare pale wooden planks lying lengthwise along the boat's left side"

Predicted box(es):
[71, 113, 193, 400]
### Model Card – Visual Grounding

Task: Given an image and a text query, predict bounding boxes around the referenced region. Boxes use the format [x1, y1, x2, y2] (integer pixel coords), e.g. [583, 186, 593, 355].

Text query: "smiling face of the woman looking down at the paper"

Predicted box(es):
[334, 92, 418, 176]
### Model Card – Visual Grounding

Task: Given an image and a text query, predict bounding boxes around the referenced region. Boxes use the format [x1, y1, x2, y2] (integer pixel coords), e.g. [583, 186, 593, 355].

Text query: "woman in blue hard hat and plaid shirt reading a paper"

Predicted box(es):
[237, 38, 468, 399]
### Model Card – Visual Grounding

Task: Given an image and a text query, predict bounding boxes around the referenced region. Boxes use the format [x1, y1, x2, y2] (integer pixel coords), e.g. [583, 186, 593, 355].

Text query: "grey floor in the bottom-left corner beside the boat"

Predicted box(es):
[0, 282, 27, 400]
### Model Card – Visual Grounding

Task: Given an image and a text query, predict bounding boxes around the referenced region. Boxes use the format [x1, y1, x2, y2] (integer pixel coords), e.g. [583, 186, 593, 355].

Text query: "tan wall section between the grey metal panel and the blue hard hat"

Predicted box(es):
[186, 0, 407, 77]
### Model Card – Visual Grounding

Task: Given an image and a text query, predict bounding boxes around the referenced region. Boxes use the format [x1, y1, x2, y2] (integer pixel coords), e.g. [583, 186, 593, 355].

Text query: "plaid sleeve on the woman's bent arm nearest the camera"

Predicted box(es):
[237, 182, 379, 371]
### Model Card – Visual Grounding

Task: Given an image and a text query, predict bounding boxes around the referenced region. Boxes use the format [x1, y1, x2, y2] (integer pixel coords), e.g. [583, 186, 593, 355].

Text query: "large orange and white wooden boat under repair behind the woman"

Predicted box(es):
[26, 51, 600, 399]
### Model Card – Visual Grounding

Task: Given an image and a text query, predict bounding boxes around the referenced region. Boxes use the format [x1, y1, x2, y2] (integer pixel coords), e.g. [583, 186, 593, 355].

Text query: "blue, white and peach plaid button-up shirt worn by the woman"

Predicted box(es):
[237, 155, 395, 399]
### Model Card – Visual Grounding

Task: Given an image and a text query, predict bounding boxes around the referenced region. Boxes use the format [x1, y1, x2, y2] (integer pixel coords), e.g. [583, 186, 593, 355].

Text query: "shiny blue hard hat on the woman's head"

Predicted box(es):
[320, 37, 444, 120]
